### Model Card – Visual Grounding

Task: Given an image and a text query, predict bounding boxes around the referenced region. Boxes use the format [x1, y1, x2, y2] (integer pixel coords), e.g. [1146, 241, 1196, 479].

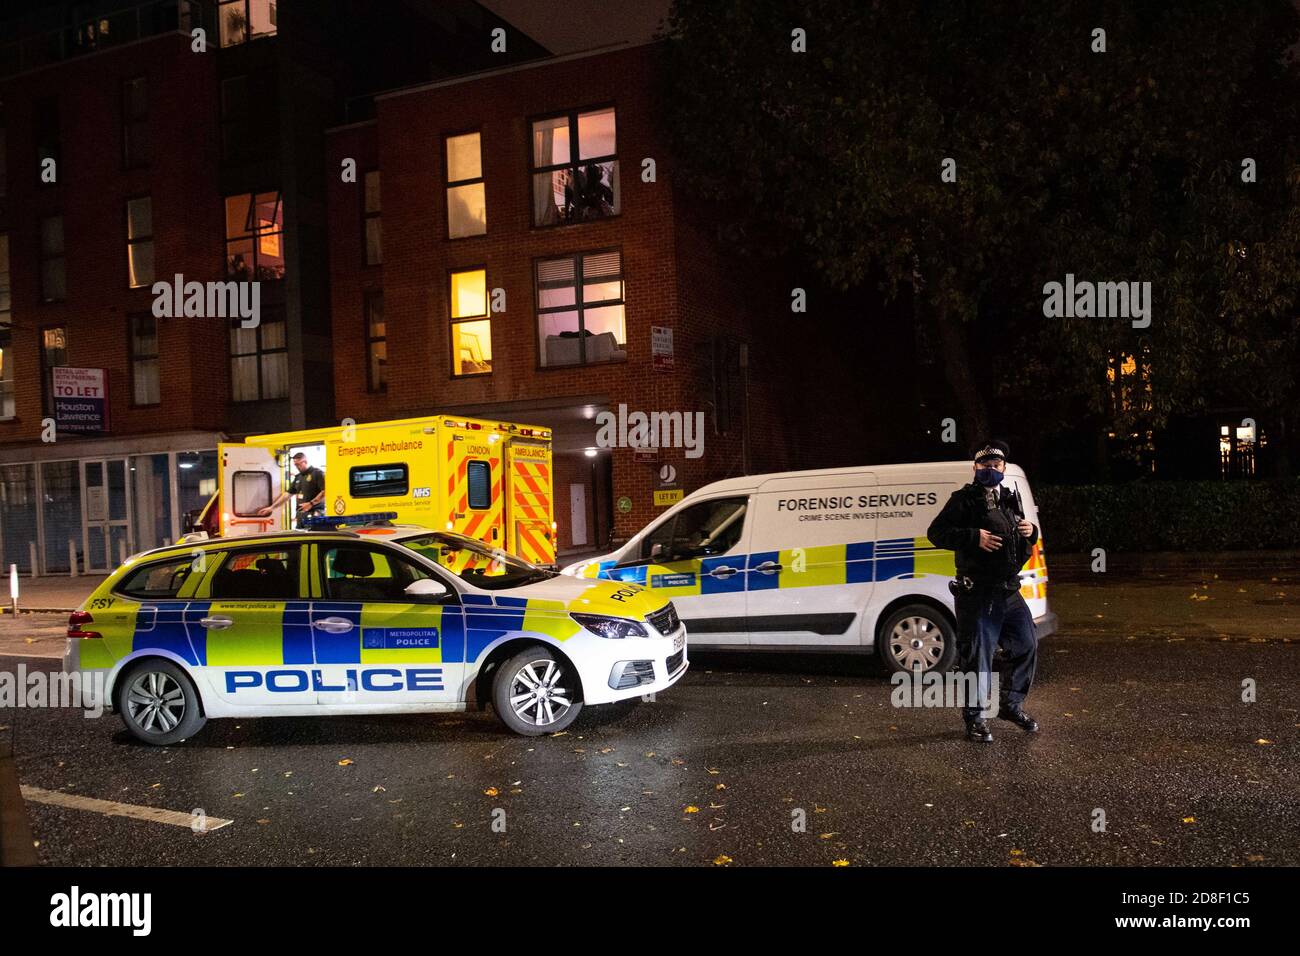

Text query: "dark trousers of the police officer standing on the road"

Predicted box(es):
[957, 587, 1039, 719]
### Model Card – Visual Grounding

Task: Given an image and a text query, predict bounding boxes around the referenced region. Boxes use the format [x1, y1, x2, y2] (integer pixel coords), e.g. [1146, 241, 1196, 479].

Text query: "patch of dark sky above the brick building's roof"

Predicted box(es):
[480, 0, 672, 53]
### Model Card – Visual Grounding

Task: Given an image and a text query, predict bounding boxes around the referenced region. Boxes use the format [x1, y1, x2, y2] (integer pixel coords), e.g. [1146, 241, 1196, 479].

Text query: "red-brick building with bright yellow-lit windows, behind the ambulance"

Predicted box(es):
[326, 44, 859, 551]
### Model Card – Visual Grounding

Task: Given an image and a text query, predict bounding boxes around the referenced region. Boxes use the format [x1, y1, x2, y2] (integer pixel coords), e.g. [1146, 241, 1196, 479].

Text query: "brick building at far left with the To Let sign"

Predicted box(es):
[0, 0, 546, 572]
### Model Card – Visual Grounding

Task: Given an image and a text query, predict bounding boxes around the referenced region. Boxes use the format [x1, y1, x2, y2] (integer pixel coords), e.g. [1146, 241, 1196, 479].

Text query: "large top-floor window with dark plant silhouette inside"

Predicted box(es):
[532, 107, 619, 226]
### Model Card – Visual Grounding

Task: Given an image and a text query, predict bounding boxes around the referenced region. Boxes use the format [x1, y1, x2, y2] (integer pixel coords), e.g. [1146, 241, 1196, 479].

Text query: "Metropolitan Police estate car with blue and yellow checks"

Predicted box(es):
[64, 525, 688, 744]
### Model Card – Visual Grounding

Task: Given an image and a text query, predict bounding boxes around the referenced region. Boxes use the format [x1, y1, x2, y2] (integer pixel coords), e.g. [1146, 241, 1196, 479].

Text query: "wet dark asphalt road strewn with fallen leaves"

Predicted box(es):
[0, 574, 1300, 866]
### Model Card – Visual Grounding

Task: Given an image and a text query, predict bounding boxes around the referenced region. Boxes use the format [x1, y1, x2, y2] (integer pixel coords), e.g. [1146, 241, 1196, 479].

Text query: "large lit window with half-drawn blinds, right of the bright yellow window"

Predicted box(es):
[537, 251, 628, 367]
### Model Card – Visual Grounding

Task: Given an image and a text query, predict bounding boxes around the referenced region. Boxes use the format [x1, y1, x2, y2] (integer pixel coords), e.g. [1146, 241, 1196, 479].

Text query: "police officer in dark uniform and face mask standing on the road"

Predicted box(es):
[927, 441, 1039, 743]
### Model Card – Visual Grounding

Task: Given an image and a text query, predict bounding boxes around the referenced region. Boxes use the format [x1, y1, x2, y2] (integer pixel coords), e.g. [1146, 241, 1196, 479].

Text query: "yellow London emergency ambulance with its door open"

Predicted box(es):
[189, 415, 555, 571]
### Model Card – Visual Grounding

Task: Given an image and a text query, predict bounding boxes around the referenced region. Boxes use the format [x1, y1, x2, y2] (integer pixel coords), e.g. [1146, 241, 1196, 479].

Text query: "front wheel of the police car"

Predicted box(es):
[491, 644, 582, 737]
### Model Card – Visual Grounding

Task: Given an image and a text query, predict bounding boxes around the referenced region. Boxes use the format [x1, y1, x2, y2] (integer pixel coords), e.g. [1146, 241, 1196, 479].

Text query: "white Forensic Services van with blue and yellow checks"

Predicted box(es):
[564, 462, 1057, 670]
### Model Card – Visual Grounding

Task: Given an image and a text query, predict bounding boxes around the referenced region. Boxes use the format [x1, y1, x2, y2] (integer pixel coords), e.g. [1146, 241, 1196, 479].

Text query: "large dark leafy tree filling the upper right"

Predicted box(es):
[666, 0, 1300, 463]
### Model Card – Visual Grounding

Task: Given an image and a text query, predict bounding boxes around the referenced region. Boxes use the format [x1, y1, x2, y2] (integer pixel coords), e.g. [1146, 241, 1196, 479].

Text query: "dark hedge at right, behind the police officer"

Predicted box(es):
[1034, 479, 1300, 554]
